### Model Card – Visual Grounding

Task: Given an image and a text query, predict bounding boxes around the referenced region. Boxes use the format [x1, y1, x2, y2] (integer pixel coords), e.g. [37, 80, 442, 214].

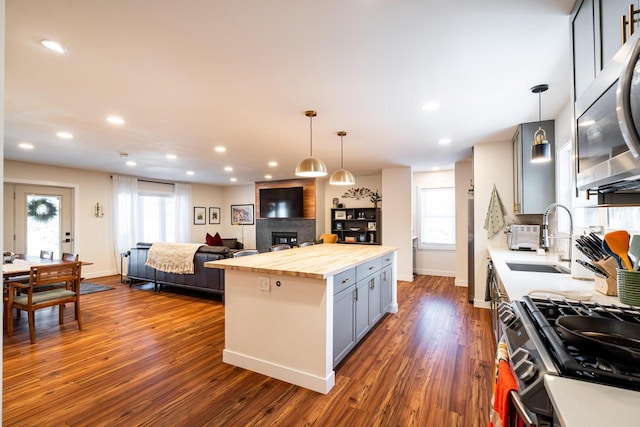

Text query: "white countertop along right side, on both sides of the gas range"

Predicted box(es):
[489, 248, 640, 427]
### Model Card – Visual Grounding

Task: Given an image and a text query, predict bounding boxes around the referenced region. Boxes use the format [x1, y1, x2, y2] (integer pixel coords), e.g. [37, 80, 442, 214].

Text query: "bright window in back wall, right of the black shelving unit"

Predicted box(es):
[419, 187, 456, 250]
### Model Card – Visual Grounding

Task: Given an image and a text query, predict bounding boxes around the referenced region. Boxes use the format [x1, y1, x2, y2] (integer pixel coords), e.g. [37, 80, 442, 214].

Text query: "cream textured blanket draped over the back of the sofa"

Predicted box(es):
[145, 242, 202, 274]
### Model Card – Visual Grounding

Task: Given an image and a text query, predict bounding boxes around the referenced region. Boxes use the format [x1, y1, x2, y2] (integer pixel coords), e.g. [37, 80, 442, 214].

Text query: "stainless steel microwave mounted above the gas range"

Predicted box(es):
[575, 33, 640, 192]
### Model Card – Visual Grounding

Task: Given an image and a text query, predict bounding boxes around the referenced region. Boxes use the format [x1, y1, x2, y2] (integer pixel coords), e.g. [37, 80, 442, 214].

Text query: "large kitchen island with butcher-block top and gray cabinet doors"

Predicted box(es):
[205, 244, 398, 393]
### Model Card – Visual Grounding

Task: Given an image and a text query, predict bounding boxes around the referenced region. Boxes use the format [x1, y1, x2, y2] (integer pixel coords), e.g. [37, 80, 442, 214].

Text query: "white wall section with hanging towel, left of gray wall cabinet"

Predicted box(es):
[473, 141, 513, 307]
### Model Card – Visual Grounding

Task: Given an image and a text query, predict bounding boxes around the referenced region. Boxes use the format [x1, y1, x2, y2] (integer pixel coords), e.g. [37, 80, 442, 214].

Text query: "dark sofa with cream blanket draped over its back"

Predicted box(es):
[125, 244, 232, 301]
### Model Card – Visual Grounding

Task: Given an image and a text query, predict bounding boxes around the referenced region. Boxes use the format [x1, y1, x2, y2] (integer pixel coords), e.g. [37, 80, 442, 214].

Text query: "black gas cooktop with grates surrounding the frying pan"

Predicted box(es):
[517, 296, 640, 390]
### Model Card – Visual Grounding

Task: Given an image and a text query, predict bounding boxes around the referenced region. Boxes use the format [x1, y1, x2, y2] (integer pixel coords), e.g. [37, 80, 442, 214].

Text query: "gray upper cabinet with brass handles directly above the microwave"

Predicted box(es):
[571, 0, 640, 100]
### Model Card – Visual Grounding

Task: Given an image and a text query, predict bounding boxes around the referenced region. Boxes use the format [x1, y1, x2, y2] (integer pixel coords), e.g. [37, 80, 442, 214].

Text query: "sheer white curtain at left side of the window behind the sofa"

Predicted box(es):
[111, 175, 138, 266]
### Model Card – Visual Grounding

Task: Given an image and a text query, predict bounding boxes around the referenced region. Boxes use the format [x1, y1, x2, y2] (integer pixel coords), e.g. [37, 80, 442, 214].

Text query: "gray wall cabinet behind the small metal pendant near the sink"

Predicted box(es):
[513, 120, 556, 214]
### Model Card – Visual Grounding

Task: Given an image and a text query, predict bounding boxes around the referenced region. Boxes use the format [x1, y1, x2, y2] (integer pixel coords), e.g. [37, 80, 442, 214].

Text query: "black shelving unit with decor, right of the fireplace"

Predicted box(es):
[331, 208, 382, 245]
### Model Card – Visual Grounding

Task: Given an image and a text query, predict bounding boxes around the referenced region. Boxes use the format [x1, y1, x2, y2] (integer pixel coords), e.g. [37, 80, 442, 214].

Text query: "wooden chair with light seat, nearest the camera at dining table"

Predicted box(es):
[5, 262, 82, 344]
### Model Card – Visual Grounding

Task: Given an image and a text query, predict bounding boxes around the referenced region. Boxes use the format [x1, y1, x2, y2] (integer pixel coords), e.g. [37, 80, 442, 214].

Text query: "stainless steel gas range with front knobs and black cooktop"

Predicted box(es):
[499, 296, 640, 426]
